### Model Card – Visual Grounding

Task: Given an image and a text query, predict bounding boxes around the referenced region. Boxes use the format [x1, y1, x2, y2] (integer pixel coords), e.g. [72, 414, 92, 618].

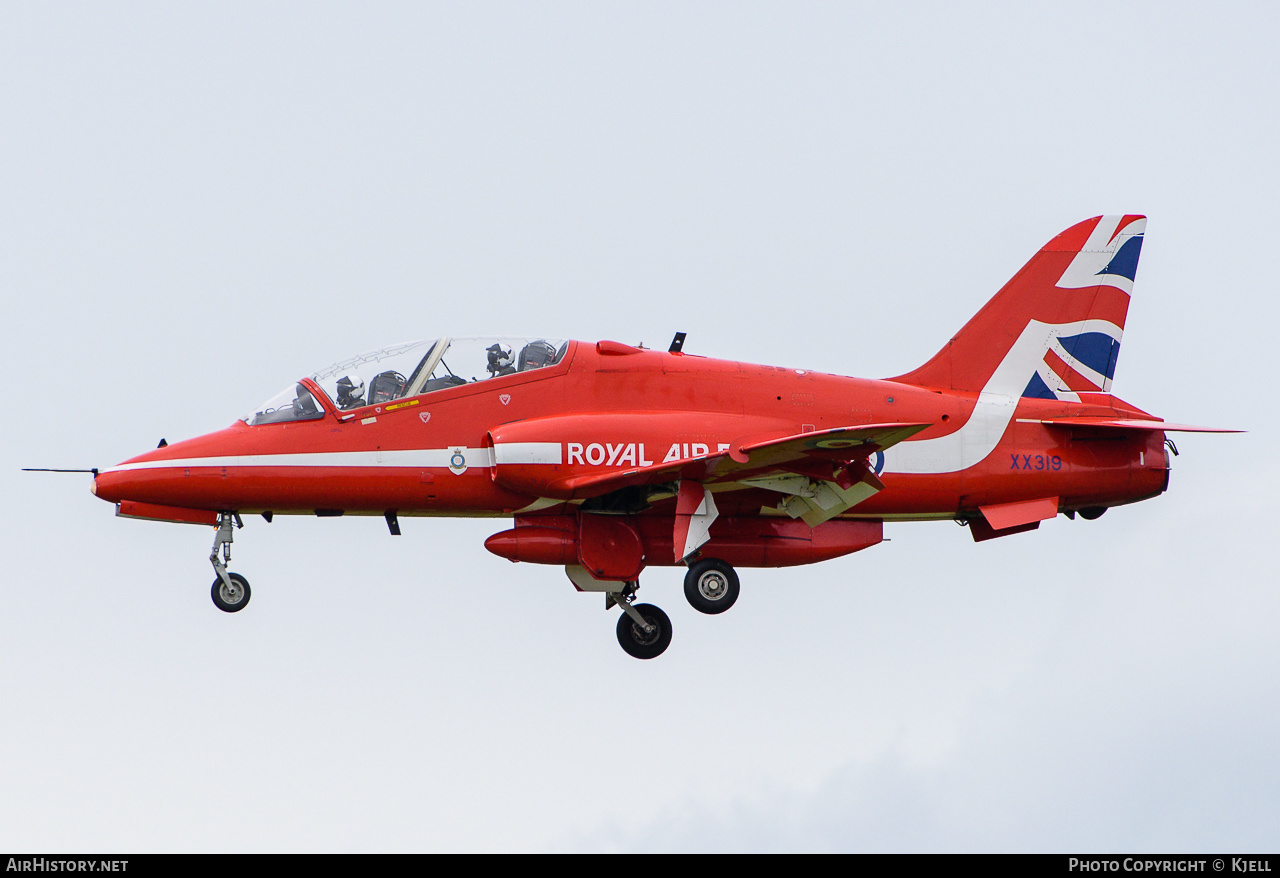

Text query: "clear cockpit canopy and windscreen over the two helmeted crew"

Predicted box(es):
[244, 338, 568, 425]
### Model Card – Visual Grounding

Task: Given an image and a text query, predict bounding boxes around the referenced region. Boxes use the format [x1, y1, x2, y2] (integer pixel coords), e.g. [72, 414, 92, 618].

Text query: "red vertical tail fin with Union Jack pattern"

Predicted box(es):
[891, 214, 1147, 402]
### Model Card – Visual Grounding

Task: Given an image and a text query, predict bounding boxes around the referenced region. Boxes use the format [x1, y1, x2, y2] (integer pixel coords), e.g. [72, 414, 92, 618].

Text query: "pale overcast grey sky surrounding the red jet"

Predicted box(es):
[0, 0, 1280, 851]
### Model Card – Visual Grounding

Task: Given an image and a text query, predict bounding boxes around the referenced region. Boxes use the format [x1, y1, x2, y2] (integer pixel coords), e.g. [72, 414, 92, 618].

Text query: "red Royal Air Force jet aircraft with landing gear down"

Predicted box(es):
[93, 215, 1228, 658]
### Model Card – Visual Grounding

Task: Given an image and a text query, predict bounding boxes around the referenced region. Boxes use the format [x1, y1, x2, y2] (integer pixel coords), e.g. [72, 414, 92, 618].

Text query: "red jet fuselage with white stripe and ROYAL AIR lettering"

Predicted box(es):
[95, 342, 1169, 529]
